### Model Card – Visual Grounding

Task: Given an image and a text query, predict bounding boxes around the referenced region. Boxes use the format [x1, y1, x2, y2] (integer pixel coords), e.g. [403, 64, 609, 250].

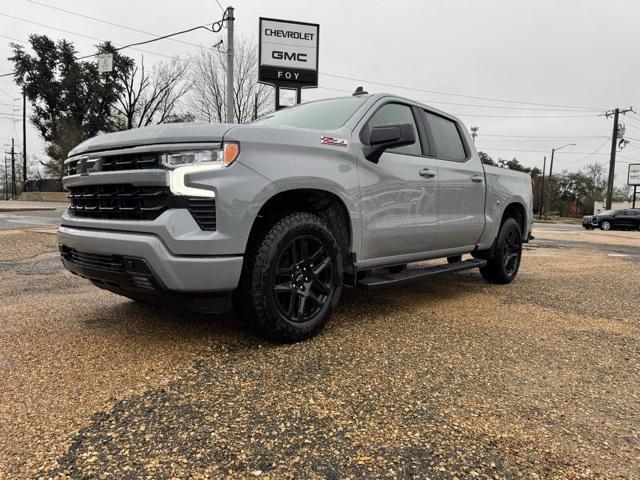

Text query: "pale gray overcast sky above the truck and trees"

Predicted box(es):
[0, 0, 640, 183]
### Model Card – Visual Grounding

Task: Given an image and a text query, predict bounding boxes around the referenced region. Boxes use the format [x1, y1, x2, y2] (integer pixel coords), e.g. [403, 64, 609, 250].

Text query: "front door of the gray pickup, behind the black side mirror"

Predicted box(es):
[358, 102, 438, 260]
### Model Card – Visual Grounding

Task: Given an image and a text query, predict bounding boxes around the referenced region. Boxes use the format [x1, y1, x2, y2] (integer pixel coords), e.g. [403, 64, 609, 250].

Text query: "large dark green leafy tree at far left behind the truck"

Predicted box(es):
[9, 35, 134, 178]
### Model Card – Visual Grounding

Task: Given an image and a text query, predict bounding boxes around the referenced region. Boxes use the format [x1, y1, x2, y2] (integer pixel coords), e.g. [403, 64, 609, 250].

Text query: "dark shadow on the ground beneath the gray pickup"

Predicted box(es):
[82, 273, 482, 348]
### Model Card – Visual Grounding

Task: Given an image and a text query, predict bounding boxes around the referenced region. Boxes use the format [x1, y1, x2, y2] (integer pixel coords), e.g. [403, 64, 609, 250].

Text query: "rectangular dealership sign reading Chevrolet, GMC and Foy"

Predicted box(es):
[258, 18, 320, 88]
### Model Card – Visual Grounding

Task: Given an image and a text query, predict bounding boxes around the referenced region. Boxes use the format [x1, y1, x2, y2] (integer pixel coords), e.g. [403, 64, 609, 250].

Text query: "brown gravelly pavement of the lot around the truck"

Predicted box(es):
[0, 227, 640, 479]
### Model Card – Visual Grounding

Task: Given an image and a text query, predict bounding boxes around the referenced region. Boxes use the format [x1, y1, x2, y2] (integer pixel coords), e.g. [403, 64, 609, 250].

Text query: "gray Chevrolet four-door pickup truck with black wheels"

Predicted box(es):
[58, 93, 532, 342]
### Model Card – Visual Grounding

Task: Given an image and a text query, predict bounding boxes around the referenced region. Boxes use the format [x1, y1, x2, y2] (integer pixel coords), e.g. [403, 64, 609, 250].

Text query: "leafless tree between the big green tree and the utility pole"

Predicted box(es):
[115, 58, 191, 129]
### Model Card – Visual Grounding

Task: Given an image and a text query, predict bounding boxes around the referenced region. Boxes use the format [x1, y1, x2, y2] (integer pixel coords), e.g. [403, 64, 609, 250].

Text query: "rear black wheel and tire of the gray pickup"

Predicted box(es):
[480, 218, 522, 285]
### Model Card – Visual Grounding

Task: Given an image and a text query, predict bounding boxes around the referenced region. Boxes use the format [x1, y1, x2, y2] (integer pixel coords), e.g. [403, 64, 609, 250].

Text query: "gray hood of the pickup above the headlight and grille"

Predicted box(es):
[69, 123, 238, 156]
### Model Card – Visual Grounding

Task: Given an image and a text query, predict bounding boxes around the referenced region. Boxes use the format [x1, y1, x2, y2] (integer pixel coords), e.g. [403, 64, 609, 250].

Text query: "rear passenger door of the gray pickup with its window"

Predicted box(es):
[421, 109, 486, 250]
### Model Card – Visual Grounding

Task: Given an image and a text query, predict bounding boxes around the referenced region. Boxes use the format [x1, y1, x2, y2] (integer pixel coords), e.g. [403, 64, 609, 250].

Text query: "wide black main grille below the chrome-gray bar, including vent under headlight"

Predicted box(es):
[67, 184, 216, 231]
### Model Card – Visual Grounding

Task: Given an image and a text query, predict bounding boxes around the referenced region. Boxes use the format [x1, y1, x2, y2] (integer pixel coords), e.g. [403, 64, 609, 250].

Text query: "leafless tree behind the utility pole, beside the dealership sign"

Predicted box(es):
[189, 38, 273, 123]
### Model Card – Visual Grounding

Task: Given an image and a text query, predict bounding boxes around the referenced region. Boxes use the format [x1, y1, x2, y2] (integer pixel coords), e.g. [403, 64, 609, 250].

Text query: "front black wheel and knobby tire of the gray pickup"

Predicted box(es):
[234, 212, 342, 343]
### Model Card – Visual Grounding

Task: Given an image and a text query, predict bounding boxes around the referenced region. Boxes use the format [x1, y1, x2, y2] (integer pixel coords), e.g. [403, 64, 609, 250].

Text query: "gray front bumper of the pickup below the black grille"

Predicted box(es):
[58, 226, 243, 294]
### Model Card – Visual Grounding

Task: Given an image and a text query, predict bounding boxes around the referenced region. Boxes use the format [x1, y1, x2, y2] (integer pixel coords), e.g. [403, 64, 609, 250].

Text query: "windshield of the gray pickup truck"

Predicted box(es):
[253, 96, 366, 130]
